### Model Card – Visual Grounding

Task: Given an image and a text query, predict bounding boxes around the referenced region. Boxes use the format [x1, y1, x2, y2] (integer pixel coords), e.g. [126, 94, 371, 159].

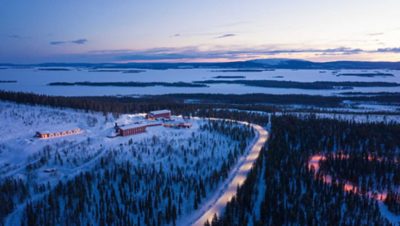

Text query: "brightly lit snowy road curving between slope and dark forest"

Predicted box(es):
[192, 124, 268, 226]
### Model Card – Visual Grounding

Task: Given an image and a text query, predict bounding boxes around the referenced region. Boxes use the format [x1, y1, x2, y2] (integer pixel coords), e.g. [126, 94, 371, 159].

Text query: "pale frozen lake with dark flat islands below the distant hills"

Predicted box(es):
[0, 68, 400, 96]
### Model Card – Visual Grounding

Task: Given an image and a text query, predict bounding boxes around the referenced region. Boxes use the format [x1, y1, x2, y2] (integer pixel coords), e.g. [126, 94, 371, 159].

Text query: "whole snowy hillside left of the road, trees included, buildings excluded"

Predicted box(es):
[0, 102, 254, 225]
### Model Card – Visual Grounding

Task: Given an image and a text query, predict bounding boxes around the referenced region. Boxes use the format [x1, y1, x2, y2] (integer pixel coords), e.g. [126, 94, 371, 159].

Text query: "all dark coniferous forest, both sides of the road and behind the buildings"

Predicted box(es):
[0, 91, 400, 226]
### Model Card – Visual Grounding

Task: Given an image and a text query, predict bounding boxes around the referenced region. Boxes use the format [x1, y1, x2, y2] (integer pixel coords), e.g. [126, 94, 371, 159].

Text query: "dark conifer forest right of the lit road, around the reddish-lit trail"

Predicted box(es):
[211, 115, 400, 226]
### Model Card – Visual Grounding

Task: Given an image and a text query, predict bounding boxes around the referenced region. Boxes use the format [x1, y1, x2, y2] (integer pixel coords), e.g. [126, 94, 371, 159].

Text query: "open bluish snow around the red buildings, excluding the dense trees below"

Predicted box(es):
[0, 102, 251, 225]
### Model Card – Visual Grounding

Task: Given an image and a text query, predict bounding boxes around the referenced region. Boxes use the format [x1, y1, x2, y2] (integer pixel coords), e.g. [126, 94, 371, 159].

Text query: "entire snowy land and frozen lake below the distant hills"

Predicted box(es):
[0, 64, 400, 226]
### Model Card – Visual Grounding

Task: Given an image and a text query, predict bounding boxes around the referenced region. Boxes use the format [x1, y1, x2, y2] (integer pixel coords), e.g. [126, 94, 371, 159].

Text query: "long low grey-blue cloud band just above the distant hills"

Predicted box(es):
[54, 46, 400, 62]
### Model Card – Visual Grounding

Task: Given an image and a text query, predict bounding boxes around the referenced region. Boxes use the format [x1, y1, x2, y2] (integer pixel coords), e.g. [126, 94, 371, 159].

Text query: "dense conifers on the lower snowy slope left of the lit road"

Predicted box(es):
[21, 118, 253, 226]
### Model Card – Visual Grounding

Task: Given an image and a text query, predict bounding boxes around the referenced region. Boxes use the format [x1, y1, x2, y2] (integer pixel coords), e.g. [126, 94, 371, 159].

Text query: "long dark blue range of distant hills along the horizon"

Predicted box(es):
[0, 59, 400, 70]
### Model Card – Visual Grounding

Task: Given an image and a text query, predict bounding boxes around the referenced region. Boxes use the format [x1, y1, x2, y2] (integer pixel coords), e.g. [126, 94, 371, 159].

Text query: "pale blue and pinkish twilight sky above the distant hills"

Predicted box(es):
[0, 0, 400, 63]
